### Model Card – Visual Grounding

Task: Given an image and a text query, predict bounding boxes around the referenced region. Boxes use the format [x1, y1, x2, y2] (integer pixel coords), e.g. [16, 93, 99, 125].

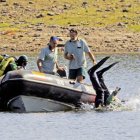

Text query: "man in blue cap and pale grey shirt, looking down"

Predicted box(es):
[37, 36, 64, 74]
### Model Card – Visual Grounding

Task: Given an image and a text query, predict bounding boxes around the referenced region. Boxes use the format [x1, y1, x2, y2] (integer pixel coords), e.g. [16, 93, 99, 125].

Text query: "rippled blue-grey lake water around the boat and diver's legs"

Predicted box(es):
[0, 55, 140, 140]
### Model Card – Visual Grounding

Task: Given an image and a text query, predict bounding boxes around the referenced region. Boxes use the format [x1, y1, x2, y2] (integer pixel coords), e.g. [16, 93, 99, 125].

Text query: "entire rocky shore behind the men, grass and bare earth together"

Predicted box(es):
[0, 0, 140, 54]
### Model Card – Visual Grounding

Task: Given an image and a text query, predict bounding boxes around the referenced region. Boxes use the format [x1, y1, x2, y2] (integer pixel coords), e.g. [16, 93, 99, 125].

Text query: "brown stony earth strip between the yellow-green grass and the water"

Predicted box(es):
[0, 24, 140, 53]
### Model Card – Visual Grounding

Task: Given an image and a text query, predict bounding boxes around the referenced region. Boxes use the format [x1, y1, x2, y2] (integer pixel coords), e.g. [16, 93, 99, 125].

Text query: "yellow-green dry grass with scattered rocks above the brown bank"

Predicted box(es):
[0, 0, 140, 32]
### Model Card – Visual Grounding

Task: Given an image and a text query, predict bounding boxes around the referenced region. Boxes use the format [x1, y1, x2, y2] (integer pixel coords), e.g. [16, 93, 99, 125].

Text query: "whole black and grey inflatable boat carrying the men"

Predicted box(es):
[0, 70, 96, 112]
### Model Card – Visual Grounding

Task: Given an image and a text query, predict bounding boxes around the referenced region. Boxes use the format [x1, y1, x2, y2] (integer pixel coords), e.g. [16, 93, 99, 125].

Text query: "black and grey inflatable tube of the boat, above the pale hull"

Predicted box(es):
[0, 70, 96, 110]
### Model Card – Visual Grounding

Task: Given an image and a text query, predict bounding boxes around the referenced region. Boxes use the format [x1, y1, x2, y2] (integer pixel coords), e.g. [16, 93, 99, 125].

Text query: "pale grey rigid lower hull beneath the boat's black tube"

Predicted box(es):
[7, 95, 74, 113]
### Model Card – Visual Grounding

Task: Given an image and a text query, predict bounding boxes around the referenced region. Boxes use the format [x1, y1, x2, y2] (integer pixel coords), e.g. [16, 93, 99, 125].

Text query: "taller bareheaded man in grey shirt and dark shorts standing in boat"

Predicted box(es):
[64, 28, 96, 83]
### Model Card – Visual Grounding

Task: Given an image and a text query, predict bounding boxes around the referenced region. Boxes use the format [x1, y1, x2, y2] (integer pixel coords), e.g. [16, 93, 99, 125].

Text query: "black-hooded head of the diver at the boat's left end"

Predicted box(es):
[16, 55, 28, 67]
